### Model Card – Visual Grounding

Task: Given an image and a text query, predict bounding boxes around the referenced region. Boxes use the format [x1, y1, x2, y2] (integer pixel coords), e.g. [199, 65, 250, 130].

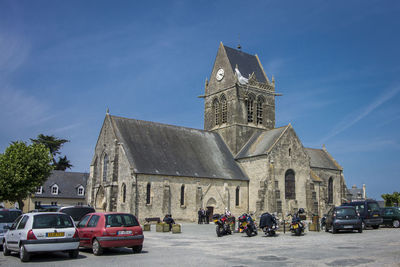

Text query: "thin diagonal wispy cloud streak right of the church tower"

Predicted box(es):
[320, 85, 400, 143]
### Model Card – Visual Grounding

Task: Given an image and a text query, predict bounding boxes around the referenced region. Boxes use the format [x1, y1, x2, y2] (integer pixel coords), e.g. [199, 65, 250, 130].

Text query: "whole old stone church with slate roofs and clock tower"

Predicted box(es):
[86, 43, 347, 221]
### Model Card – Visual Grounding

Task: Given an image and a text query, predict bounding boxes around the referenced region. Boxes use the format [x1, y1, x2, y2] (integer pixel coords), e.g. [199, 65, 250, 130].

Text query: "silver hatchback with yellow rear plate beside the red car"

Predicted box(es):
[3, 212, 79, 261]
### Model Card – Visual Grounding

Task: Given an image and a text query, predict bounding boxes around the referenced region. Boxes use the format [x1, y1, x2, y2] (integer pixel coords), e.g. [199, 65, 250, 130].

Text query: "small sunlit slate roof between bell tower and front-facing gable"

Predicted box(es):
[236, 125, 289, 159]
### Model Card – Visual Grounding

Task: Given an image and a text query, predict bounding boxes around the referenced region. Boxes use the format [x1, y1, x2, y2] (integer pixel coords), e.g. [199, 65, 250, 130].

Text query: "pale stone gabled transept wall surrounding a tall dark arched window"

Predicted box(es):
[239, 126, 311, 219]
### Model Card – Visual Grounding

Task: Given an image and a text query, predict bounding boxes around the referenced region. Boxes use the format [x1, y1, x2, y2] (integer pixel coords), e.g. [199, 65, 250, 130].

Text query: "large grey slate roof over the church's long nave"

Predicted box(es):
[110, 116, 248, 180]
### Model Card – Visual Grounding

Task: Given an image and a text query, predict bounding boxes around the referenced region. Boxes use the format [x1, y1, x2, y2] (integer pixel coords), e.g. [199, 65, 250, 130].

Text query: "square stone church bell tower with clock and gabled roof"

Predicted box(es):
[201, 43, 277, 155]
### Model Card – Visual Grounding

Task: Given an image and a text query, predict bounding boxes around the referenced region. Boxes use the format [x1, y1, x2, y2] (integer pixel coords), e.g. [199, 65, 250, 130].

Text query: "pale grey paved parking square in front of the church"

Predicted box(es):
[0, 224, 400, 266]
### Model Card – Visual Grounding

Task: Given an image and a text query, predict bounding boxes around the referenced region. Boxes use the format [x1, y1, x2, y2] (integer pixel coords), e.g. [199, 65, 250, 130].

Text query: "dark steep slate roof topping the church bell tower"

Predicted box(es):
[224, 45, 267, 83]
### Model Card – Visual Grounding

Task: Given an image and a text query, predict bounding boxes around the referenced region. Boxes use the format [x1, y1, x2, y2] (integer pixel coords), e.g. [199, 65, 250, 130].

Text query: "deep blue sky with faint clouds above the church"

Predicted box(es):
[0, 0, 400, 199]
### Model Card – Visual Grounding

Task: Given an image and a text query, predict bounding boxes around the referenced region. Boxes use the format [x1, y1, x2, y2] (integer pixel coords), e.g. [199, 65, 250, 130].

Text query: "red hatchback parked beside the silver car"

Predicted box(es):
[77, 212, 144, 256]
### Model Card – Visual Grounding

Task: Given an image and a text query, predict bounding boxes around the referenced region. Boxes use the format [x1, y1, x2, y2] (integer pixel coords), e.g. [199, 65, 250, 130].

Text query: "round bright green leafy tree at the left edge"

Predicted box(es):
[0, 142, 53, 210]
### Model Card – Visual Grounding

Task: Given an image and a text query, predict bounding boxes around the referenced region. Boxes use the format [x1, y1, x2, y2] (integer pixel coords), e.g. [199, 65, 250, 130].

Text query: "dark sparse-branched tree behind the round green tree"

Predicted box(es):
[31, 134, 73, 171]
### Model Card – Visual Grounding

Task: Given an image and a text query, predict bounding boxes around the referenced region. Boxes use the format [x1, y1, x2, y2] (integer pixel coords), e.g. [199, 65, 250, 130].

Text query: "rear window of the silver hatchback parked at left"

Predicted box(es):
[32, 214, 74, 229]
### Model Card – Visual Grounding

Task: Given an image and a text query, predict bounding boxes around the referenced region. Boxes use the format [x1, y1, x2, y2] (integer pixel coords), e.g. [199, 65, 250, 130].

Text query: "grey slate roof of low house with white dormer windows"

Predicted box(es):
[35, 170, 89, 199]
